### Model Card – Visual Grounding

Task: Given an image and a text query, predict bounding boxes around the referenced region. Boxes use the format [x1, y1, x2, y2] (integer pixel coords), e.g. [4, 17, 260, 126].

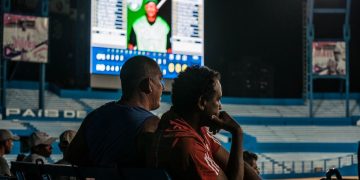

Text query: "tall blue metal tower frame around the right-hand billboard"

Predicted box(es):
[306, 0, 351, 117]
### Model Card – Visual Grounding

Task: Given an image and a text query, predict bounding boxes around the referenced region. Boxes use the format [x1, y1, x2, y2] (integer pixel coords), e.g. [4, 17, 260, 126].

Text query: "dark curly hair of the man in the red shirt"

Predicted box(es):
[171, 66, 220, 115]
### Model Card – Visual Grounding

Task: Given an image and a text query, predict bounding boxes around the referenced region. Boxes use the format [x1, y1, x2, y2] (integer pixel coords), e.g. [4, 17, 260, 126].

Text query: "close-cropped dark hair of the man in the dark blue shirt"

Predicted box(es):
[120, 56, 161, 98]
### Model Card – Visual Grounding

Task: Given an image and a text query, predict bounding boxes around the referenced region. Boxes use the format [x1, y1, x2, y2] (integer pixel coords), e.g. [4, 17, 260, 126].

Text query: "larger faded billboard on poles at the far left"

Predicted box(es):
[3, 13, 49, 63]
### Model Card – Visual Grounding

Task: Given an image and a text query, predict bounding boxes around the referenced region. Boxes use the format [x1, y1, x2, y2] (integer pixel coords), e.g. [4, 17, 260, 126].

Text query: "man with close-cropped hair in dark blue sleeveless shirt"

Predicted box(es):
[65, 56, 163, 167]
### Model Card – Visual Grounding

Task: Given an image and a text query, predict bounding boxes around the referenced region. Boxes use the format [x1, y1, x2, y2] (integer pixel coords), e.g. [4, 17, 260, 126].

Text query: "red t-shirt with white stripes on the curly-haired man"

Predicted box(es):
[157, 119, 220, 179]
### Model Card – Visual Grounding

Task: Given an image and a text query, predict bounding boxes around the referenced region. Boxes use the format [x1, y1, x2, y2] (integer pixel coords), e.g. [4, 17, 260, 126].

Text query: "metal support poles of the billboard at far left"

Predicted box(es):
[0, 0, 49, 119]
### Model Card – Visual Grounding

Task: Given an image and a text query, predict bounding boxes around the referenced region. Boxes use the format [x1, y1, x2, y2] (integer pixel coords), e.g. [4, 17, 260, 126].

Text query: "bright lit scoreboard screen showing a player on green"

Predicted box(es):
[90, 0, 204, 79]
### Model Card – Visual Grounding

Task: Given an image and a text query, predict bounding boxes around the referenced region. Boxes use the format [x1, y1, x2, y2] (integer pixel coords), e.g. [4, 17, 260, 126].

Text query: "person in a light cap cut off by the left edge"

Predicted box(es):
[0, 129, 19, 176]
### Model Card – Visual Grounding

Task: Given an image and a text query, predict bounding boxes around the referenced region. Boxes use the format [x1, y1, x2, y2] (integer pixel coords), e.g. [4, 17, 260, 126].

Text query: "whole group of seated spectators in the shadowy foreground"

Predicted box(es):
[0, 56, 270, 179]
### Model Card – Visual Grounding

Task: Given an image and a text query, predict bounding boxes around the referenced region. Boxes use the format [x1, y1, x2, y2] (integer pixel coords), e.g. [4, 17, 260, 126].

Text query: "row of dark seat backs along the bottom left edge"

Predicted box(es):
[11, 161, 170, 180]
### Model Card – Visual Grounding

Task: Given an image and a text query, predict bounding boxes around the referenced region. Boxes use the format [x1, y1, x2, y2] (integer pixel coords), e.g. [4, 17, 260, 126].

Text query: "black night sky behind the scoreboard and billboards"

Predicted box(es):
[3, 0, 360, 98]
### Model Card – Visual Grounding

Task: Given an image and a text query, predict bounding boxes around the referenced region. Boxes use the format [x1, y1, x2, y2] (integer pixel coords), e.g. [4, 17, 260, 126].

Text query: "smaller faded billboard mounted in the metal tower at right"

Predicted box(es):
[312, 41, 346, 76]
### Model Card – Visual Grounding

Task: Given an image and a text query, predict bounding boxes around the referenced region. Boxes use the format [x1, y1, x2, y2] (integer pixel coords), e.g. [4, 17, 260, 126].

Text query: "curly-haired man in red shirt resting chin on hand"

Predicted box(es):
[149, 67, 261, 179]
